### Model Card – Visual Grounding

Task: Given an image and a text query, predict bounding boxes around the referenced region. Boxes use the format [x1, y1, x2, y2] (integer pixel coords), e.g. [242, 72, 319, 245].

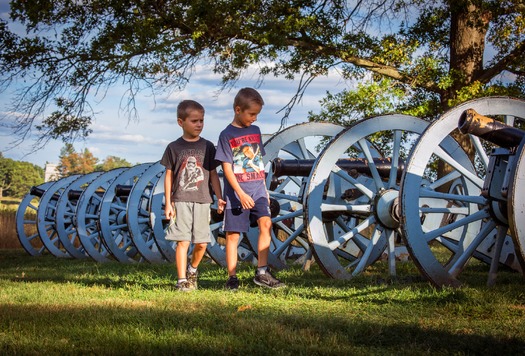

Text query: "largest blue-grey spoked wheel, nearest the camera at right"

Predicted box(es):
[400, 97, 525, 287]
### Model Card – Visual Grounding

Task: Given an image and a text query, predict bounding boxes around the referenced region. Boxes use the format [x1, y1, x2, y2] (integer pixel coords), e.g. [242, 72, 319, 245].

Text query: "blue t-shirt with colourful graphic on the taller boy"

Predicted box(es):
[215, 124, 268, 209]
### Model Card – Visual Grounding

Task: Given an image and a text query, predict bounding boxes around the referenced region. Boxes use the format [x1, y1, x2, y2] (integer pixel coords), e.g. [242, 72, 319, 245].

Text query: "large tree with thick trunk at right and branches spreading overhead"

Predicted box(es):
[0, 0, 525, 149]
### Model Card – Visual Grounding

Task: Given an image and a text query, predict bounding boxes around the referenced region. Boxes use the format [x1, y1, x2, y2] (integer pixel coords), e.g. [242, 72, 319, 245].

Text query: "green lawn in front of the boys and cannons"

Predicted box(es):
[0, 250, 525, 355]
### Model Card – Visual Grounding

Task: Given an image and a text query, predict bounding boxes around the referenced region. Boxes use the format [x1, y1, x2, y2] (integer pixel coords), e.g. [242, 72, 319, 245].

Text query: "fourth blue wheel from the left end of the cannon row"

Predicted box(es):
[76, 168, 128, 262]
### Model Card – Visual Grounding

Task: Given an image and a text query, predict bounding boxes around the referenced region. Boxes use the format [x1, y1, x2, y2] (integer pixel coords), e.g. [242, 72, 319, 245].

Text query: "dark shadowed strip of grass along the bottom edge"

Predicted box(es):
[0, 301, 525, 355]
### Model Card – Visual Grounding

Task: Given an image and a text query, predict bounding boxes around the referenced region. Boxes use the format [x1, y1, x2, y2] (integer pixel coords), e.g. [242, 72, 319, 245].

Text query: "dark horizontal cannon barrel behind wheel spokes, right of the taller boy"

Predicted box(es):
[272, 158, 405, 178]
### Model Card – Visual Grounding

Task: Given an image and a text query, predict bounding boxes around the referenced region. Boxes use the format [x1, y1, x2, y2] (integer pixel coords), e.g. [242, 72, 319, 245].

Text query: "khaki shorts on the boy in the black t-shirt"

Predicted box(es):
[166, 202, 211, 243]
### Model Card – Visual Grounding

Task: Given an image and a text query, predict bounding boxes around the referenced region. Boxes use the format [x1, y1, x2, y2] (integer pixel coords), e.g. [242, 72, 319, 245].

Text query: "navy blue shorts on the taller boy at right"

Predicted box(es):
[222, 198, 271, 232]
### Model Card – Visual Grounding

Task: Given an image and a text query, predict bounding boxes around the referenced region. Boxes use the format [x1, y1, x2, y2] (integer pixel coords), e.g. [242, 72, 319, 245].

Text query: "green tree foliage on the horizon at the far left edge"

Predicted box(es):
[0, 154, 44, 198]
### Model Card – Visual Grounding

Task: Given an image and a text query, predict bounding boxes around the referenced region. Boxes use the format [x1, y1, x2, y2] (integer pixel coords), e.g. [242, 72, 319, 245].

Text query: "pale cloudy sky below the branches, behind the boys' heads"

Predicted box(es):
[0, 0, 348, 167]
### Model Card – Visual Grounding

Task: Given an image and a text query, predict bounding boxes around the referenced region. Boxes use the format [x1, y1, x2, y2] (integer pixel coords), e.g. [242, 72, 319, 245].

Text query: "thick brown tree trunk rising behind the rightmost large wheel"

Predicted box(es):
[438, 0, 490, 176]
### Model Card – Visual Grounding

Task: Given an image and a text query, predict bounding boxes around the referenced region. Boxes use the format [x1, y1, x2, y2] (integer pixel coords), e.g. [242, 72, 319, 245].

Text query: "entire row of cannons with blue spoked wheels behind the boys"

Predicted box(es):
[16, 97, 525, 287]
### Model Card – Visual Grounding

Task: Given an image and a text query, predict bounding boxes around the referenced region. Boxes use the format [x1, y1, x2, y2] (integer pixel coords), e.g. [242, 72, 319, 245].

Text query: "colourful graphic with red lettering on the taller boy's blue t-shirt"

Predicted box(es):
[230, 135, 265, 182]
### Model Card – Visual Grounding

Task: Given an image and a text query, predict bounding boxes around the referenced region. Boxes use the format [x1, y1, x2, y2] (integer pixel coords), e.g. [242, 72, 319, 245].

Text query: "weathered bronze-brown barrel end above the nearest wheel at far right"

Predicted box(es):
[458, 109, 525, 148]
